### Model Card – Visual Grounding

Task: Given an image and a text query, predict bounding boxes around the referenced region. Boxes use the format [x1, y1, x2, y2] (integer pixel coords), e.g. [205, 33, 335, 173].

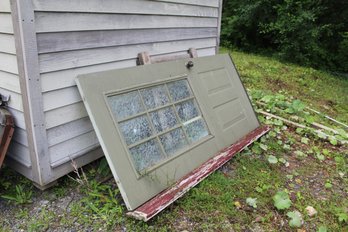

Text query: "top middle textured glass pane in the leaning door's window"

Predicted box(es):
[140, 85, 169, 109]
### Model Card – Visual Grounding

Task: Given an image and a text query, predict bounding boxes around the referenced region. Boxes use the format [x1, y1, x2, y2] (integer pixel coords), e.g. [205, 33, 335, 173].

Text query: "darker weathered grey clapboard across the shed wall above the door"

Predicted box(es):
[36, 28, 217, 53]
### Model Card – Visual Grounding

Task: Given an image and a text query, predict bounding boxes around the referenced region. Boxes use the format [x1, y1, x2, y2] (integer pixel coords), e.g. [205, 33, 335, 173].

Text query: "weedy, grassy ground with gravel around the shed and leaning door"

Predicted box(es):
[0, 52, 348, 232]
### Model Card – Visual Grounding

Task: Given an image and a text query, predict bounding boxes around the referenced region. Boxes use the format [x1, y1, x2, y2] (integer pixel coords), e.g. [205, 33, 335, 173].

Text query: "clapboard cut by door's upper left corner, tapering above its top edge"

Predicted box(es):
[41, 58, 136, 92]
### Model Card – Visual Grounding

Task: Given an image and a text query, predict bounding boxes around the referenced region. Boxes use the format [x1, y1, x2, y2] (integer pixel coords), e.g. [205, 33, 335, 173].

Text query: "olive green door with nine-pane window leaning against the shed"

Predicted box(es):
[77, 55, 259, 210]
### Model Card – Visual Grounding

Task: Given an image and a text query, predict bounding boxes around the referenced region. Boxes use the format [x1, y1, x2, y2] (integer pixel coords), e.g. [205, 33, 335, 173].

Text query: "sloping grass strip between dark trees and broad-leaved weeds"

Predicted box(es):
[221, 49, 348, 124]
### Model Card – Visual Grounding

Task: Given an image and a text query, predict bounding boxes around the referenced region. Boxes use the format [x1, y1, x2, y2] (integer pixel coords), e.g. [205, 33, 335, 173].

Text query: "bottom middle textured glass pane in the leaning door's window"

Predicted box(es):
[160, 128, 187, 155]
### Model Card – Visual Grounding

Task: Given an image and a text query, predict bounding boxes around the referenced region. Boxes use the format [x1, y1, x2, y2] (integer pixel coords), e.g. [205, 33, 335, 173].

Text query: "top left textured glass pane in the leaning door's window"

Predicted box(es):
[108, 91, 145, 120]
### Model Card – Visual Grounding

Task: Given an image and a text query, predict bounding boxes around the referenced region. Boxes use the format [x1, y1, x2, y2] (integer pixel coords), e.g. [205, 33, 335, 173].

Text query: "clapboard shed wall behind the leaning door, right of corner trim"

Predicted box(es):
[33, 0, 219, 168]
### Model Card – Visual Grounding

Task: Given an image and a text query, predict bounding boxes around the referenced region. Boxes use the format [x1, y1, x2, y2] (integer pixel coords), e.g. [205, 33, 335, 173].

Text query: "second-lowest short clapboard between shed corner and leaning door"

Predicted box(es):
[47, 117, 93, 147]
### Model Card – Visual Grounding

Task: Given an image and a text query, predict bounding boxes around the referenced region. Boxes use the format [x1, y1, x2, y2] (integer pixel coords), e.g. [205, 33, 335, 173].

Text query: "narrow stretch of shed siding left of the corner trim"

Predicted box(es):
[0, 0, 31, 169]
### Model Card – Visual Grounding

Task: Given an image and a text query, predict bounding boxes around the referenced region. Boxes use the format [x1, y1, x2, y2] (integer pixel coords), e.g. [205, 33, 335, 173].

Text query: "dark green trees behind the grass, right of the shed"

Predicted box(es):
[221, 0, 348, 72]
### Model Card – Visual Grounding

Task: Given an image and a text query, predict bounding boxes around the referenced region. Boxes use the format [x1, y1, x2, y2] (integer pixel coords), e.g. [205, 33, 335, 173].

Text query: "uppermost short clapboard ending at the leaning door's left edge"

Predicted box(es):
[42, 86, 82, 112]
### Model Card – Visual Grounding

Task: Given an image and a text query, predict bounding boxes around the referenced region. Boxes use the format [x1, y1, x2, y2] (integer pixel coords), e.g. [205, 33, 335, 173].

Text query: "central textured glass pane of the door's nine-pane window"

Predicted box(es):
[150, 107, 178, 132]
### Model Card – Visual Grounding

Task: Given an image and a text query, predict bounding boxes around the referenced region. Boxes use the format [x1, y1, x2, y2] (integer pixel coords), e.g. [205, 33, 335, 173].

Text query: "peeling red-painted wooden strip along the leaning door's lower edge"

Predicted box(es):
[127, 126, 270, 222]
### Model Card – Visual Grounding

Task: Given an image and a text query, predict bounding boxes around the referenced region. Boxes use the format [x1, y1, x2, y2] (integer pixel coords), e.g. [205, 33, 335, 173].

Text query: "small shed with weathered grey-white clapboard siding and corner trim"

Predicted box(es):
[0, 0, 222, 189]
